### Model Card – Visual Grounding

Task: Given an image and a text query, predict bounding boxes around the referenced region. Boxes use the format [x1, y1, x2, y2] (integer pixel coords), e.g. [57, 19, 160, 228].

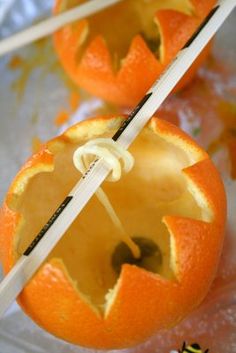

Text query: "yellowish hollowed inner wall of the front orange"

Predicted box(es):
[14, 125, 203, 313]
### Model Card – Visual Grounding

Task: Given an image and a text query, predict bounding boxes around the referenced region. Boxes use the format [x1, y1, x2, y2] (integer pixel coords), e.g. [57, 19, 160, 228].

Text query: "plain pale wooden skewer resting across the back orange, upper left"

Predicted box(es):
[0, 0, 122, 56]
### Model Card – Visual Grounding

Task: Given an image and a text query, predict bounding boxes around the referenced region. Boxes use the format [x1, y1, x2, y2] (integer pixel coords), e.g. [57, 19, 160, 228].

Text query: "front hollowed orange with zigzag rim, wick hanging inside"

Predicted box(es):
[0, 116, 226, 349]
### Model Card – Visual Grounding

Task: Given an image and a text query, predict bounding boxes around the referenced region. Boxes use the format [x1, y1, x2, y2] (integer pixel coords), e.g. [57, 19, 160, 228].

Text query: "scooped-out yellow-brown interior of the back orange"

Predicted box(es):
[59, 0, 193, 69]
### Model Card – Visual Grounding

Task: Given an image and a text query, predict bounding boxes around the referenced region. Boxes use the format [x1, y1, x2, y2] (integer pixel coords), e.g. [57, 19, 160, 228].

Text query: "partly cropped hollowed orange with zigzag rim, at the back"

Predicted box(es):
[54, 0, 215, 107]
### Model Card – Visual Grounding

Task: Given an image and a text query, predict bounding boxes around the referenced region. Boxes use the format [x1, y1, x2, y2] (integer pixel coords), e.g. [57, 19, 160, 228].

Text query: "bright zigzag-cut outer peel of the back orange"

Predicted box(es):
[54, 0, 216, 107]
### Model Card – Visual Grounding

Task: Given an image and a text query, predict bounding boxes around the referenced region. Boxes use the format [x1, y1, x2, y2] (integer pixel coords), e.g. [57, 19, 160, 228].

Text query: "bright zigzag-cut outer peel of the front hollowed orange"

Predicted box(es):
[0, 117, 226, 349]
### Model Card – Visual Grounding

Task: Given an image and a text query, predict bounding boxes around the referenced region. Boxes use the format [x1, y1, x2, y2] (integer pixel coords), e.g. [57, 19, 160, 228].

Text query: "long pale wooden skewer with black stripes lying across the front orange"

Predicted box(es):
[0, 0, 236, 316]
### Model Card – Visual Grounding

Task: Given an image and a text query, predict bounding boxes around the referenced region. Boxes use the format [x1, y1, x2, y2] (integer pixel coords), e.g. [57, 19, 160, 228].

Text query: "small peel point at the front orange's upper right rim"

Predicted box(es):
[183, 158, 226, 221]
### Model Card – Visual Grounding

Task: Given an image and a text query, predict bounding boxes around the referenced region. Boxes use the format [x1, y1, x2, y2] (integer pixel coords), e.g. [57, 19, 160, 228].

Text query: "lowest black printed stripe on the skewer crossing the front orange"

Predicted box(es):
[23, 196, 73, 256]
